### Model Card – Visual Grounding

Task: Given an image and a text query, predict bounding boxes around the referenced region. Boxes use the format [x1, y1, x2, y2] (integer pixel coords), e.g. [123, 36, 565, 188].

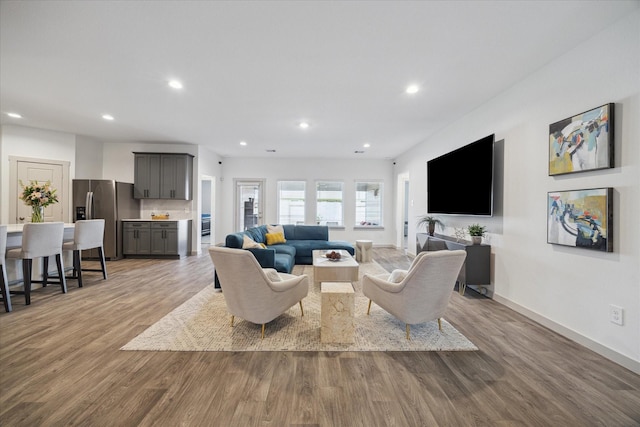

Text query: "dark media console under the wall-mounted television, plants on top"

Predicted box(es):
[416, 233, 491, 295]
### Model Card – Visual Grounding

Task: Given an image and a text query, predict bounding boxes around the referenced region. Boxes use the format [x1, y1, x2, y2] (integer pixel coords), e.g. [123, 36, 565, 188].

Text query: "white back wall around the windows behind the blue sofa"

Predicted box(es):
[218, 158, 396, 245]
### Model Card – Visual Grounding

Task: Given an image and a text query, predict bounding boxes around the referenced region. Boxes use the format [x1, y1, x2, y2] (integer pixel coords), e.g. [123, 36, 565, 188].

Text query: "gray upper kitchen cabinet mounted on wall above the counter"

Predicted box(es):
[133, 152, 193, 200]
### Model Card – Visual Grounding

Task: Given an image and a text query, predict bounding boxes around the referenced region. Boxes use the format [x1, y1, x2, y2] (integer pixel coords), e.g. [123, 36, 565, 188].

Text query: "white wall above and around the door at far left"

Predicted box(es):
[0, 125, 76, 224]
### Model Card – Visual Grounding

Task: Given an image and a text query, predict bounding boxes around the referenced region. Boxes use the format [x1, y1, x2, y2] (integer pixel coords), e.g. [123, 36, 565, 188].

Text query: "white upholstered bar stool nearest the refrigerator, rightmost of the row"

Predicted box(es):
[62, 219, 107, 288]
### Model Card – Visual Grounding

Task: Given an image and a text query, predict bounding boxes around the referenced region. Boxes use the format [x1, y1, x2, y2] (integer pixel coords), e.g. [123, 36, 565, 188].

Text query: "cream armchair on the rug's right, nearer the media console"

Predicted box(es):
[362, 250, 467, 339]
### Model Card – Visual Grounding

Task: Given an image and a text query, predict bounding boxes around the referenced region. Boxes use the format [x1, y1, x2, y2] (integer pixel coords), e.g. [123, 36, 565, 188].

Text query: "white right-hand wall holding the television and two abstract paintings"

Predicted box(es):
[396, 11, 640, 372]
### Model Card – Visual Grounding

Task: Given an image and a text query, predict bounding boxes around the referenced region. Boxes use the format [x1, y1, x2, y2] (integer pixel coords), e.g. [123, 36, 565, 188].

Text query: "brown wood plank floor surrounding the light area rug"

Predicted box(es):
[0, 249, 640, 427]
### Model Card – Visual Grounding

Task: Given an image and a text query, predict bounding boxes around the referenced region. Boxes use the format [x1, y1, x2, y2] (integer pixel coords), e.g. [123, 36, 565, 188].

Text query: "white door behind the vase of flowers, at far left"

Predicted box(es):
[15, 160, 68, 224]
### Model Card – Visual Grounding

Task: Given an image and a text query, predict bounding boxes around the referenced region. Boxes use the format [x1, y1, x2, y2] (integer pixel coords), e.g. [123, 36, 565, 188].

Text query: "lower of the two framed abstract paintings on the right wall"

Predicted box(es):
[547, 187, 613, 252]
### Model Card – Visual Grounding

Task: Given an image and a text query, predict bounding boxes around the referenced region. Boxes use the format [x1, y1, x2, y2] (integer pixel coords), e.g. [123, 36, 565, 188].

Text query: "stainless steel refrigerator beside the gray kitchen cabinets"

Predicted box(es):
[73, 179, 140, 260]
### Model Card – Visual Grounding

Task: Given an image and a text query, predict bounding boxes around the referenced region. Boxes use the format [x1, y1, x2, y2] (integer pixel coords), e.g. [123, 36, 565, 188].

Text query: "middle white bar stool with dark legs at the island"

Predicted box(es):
[7, 222, 67, 305]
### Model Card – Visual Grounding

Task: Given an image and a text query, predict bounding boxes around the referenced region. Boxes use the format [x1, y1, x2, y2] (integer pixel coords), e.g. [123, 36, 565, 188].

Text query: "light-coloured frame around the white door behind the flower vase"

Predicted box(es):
[8, 156, 73, 224]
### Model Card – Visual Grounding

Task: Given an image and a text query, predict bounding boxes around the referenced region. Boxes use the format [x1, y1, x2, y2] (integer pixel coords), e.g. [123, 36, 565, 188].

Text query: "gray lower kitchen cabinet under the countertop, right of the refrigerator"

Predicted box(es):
[123, 220, 190, 258]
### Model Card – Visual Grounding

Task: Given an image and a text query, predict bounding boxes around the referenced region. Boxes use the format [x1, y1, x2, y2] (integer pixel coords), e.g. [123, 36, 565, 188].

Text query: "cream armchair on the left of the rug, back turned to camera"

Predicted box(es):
[209, 246, 309, 338]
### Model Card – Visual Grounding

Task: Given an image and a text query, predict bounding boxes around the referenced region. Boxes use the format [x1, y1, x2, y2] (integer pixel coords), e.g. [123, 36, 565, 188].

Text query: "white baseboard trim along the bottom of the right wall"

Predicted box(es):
[493, 293, 640, 374]
